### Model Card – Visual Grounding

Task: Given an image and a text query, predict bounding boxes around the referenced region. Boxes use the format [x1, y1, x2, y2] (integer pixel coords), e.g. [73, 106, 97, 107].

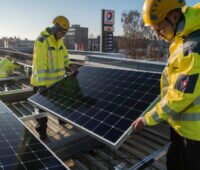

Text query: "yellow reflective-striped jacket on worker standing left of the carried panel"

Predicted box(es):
[31, 28, 70, 86]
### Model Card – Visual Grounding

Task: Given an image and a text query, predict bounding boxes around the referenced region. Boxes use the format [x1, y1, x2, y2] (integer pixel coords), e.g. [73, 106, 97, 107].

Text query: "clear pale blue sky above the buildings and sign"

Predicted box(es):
[0, 0, 199, 40]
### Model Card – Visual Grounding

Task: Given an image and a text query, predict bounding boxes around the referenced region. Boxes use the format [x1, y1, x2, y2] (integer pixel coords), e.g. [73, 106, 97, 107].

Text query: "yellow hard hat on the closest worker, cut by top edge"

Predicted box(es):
[142, 0, 185, 26]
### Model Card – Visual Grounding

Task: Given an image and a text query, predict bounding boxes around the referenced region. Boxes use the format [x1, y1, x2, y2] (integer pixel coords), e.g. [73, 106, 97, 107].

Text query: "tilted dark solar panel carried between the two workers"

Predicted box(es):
[29, 66, 160, 148]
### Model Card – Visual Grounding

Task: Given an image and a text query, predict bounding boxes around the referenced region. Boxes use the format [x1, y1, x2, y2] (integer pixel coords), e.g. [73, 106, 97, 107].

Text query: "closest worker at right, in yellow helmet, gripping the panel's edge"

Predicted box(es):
[133, 0, 200, 170]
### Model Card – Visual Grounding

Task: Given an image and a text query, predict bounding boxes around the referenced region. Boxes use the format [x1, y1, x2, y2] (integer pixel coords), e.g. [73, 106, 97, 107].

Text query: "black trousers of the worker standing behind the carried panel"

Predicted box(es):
[33, 87, 48, 136]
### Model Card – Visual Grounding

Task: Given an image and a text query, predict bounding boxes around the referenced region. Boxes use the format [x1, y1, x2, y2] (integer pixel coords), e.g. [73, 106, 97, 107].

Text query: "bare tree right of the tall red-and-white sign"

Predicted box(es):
[121, 10, 165, 60]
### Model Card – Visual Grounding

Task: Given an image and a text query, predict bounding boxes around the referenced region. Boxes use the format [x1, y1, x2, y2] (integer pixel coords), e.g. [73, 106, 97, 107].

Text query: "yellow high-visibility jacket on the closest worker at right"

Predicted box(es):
[144, 7, 200, 141]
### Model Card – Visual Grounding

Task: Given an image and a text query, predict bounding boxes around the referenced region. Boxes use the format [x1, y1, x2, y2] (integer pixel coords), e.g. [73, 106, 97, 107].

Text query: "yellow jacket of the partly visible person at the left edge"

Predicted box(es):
[0, 57, 17, 78]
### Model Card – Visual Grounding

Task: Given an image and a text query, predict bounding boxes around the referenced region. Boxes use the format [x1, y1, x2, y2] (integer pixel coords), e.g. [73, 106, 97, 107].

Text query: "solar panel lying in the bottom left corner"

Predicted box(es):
[0, 101, 67, 170]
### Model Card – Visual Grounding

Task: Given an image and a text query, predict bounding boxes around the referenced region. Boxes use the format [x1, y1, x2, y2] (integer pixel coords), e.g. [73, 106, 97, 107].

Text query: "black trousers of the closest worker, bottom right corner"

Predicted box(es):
[167, 128, 200, 170]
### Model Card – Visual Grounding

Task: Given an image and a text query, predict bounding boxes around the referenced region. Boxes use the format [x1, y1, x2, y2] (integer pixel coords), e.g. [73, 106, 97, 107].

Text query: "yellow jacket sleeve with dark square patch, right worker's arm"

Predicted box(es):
[144, 45, 200, 126]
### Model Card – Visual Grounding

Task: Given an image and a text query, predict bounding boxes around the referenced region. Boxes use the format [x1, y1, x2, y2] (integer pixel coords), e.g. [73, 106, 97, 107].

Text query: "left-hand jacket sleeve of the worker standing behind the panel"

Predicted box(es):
[33, 39, 48, 86]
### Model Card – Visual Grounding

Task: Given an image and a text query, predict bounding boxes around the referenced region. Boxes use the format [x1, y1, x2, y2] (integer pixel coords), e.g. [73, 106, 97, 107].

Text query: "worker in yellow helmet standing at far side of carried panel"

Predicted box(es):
[31, 16, 77, 139]
